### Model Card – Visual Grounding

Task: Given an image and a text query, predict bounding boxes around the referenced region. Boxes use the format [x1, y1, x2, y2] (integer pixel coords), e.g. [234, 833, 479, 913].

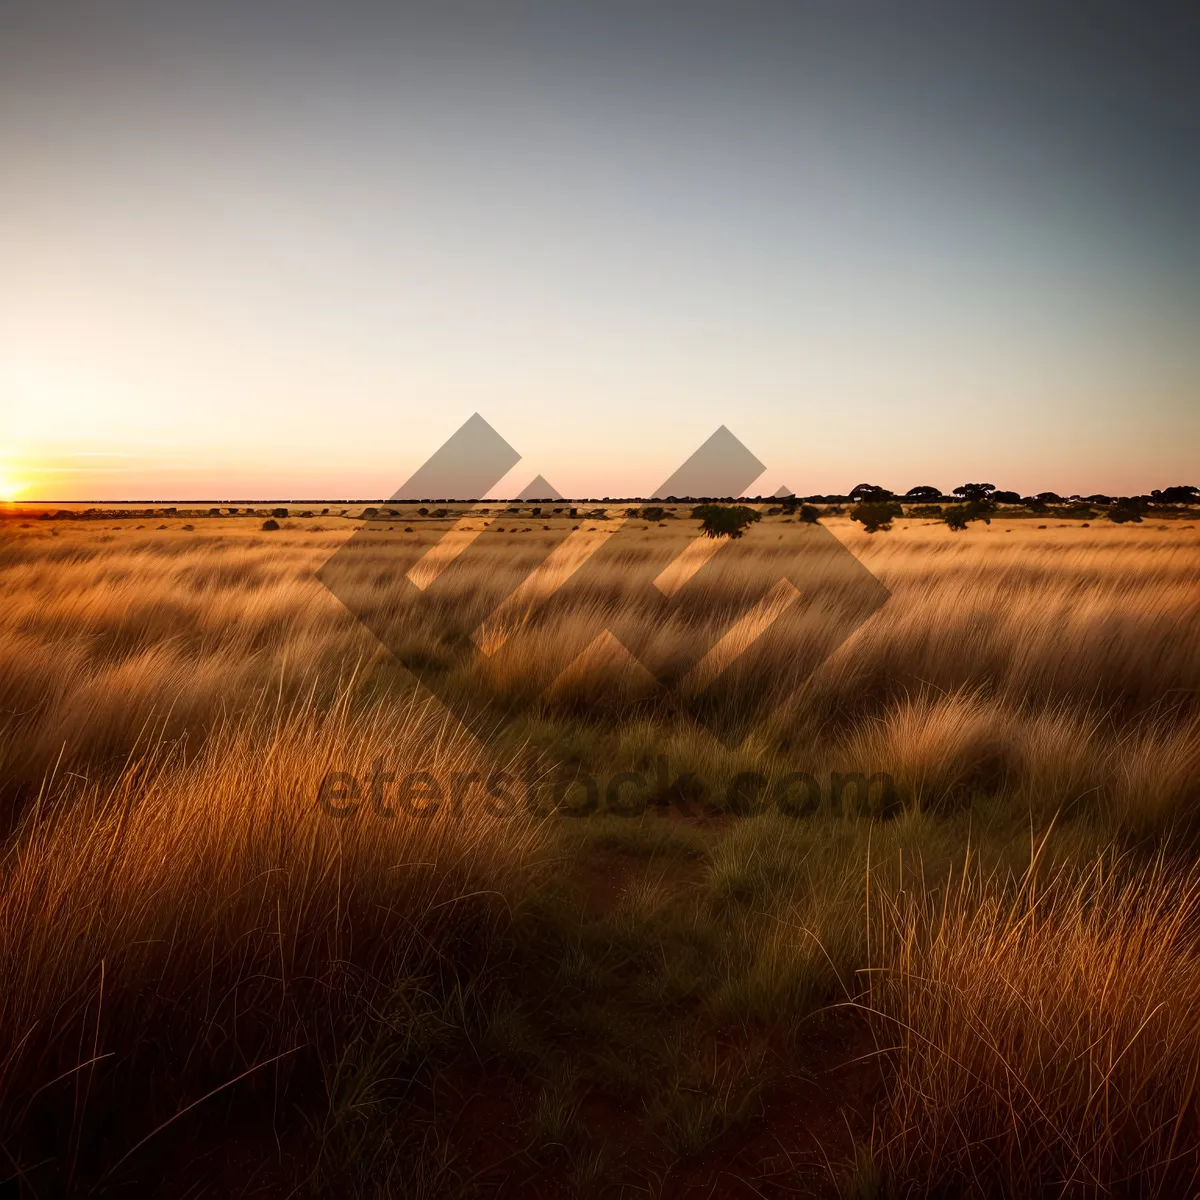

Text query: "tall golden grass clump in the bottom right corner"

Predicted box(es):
[869, 859, 1200, 1195]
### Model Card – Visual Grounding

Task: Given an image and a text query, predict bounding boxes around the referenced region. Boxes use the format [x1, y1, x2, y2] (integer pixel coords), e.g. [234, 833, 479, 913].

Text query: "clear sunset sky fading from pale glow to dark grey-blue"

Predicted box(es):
[0, 0, 1200, 500]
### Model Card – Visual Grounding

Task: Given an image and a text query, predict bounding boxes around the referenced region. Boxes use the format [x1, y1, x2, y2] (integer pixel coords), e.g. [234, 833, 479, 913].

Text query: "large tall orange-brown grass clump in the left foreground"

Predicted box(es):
[0, 672, 544, 1186]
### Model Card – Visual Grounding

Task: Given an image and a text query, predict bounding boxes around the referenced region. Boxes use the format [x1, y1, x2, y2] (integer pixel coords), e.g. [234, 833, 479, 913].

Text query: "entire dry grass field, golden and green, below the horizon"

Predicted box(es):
[0, 508, 1200, 1198]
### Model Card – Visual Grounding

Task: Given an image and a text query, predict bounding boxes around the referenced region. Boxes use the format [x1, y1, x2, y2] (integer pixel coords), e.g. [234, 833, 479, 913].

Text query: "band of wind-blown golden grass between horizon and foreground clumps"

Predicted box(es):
[0, 521, 1200, 818]
